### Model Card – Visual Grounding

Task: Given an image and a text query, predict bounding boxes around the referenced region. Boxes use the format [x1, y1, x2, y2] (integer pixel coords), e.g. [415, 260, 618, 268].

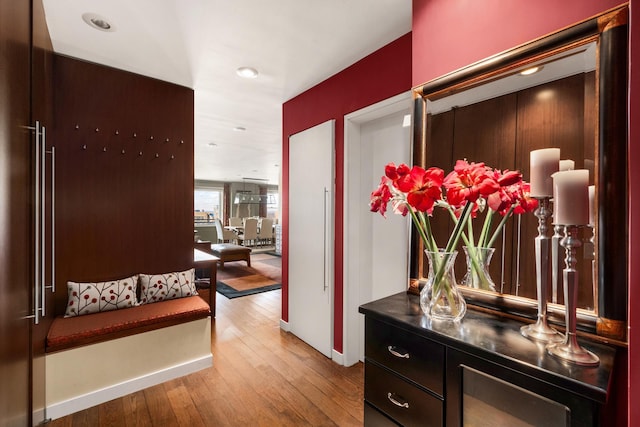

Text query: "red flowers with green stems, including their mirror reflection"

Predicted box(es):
[370, 160, 537, 320]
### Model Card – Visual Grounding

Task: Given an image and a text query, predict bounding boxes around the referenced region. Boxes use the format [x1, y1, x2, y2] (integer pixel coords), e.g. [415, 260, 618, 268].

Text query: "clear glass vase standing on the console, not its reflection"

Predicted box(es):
[420, 251, 467, 322]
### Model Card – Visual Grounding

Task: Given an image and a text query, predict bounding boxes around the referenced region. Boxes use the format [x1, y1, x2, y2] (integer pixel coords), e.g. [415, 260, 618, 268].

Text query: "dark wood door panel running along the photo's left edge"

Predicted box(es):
[0, 1, 32, 425]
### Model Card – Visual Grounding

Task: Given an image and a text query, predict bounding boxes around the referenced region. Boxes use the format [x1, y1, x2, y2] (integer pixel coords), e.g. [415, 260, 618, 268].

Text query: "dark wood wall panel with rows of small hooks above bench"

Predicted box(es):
[49, 56, 194, 314]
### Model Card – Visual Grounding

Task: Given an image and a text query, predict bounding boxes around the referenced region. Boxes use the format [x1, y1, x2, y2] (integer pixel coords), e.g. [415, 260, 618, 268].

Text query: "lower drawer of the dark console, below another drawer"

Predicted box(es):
[364, 362, 444, 427]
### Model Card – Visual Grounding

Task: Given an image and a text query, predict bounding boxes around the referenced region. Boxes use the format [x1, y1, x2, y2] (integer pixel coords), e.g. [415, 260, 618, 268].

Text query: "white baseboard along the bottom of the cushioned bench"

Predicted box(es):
[46, 354, 213, 420]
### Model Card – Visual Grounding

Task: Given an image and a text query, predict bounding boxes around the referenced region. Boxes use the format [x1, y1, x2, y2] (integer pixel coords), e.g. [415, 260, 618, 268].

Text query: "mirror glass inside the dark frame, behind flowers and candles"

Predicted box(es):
[425, 39, 598, 311]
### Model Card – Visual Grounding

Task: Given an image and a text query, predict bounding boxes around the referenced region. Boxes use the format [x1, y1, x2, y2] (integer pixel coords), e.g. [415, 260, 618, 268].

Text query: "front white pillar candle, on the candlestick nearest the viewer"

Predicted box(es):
[553, 169, 589, 225]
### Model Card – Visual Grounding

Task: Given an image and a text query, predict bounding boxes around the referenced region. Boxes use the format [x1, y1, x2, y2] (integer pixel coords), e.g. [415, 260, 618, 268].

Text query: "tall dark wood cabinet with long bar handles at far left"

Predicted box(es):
[0, 0, 52, 426]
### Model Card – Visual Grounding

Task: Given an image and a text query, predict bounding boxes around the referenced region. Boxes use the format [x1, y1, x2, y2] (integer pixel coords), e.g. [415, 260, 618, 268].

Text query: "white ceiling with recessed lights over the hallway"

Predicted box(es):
[44, 0, 411, 184]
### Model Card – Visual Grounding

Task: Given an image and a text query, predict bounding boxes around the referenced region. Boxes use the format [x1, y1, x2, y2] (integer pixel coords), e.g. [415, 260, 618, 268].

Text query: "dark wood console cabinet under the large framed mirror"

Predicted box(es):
[359, 293, 616, 427]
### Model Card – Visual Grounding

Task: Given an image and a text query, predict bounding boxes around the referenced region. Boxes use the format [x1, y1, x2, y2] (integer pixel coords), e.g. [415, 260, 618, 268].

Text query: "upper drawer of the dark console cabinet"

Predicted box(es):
[365, 318, 444, 396]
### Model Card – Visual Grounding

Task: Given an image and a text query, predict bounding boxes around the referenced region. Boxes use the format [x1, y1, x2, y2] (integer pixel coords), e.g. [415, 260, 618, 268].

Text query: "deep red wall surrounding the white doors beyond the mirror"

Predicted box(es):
[282, 33, 411, 353]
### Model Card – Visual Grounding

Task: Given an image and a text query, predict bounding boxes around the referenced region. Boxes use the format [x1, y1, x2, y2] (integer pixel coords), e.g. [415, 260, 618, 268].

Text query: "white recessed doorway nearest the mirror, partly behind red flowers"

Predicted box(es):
[343, 93, 412, 366]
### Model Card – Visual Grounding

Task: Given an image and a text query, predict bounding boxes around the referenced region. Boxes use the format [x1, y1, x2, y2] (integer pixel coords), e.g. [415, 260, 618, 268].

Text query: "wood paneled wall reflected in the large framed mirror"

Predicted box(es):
[427, 72, 596, 309]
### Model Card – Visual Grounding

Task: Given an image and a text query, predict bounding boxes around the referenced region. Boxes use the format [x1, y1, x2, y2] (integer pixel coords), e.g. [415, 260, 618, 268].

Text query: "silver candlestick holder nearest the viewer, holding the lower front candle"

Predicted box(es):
[547, 225, 600, 366]
